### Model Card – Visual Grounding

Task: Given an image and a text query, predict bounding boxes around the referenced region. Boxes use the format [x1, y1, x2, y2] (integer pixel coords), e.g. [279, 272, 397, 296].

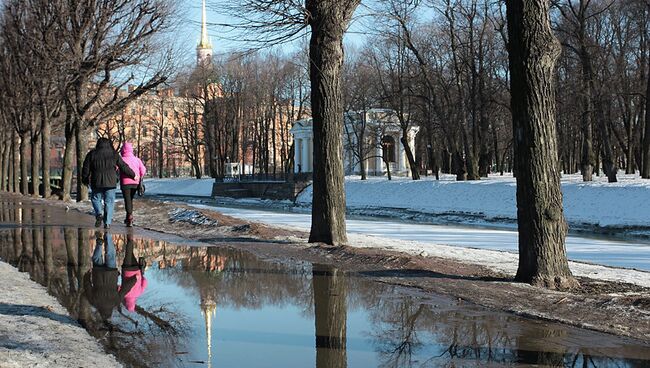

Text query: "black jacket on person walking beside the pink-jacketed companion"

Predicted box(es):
[81, 138, 135, 189]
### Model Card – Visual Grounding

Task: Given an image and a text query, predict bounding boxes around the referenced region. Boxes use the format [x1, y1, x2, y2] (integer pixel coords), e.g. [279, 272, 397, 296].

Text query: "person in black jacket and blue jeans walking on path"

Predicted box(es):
[81, 138, 140, 229]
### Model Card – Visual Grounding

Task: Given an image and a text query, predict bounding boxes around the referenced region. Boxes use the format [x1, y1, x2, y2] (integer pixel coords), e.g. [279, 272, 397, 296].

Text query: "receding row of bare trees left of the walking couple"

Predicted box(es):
[0, 0, 173, 200]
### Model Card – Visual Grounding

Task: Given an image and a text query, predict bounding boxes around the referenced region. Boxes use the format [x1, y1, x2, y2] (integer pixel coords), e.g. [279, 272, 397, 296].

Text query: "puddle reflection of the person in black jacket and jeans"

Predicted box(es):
[83, 231, 136, 321]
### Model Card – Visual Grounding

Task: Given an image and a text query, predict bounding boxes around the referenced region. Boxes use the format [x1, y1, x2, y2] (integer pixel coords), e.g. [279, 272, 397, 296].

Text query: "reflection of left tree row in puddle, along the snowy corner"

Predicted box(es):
[0, 228, 187, 366]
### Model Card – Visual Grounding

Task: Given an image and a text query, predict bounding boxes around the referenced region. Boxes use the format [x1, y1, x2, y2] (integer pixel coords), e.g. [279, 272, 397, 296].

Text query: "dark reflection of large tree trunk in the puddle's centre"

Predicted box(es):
[312, 264, 348, 368]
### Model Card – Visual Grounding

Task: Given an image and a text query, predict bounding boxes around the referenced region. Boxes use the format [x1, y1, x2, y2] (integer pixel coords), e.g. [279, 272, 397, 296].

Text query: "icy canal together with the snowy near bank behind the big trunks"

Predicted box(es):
[181, 204, 650, 287]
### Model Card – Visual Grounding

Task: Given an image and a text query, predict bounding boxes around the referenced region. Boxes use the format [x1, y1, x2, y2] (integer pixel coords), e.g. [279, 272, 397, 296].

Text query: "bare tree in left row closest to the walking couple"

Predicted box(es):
[49, 0, 172, 200]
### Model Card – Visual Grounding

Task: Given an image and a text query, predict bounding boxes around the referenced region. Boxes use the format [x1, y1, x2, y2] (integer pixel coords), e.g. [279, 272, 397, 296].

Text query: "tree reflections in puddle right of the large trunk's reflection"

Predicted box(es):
[360, 286, 647, 367]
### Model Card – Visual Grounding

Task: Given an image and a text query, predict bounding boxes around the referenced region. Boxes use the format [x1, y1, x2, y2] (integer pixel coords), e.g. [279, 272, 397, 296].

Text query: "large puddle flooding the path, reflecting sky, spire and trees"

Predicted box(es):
[0, 198, 650, 368]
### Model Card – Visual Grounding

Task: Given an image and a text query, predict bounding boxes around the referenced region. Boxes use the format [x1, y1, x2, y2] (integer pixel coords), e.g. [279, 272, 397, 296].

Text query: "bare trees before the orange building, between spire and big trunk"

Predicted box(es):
[171, 52, 307, 177]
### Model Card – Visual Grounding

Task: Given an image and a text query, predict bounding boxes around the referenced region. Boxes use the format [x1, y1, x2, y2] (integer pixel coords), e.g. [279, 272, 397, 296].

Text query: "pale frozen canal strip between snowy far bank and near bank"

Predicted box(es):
[186, 204, 650, 271]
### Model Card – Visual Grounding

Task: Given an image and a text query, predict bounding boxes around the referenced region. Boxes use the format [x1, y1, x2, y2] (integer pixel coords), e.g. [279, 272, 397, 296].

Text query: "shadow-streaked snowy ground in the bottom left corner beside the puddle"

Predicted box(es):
[0, 261, 122, 368]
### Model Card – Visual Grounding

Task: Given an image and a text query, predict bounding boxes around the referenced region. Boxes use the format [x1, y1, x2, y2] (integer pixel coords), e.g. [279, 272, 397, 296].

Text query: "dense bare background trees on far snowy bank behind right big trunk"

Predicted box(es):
[336, 0, 650, 182]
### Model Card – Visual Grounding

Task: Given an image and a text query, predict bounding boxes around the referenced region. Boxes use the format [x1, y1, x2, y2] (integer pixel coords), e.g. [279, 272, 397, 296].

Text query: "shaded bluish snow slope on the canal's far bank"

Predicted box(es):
[145, 174, 650, 227]
